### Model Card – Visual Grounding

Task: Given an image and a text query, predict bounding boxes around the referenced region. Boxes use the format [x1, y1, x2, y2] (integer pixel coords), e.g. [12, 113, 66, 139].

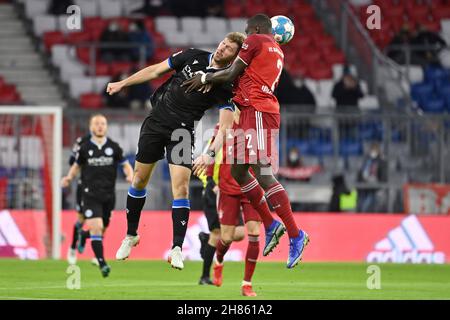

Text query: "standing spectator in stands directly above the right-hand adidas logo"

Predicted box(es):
[357, 143, 387, 212]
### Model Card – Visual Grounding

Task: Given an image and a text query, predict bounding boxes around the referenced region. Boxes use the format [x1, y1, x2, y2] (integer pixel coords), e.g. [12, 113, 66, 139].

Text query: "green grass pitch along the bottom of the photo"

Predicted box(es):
[0, 259, 450, 300]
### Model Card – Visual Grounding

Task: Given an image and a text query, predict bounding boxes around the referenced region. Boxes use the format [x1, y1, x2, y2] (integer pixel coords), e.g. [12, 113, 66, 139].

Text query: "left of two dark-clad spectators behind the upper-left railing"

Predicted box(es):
[100, 21, 130, 62]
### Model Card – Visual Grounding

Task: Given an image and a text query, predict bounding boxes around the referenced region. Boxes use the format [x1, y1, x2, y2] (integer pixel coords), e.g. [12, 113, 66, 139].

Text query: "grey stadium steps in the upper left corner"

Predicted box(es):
[0, 4, 66, 106]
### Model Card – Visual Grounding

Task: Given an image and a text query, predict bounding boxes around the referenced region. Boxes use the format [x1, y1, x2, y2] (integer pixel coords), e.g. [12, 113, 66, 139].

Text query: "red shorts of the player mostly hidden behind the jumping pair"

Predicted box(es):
[217, 192, 261, 226]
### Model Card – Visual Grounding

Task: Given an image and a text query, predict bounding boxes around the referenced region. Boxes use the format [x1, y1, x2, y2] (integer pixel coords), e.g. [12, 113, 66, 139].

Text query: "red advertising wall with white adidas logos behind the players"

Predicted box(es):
[0, 210, 450, 263]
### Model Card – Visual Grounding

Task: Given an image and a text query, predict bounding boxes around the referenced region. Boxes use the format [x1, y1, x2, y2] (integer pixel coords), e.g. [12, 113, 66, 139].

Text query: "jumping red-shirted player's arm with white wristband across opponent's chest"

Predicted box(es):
[181, 58, 247, 92]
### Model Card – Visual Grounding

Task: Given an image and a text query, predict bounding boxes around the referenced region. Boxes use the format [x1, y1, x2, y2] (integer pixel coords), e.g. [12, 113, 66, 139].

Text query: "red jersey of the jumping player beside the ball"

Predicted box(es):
[233, 34, 284, 113]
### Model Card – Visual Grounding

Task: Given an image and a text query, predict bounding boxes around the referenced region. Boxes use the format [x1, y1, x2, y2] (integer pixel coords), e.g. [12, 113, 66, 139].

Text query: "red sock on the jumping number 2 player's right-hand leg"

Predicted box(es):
[266, 182, 299, 238]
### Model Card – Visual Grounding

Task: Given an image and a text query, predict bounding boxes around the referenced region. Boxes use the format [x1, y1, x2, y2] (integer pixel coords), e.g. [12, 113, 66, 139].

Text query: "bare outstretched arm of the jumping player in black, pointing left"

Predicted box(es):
[106, 59, 172, 95]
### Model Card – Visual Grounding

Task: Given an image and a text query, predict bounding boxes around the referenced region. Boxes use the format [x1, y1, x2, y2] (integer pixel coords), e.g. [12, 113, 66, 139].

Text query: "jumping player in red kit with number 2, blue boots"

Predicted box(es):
[182, 14, 309, 268]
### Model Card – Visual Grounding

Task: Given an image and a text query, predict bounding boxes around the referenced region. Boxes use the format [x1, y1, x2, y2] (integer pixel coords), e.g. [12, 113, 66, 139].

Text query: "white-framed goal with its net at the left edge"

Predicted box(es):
[0, 106, 62, 259]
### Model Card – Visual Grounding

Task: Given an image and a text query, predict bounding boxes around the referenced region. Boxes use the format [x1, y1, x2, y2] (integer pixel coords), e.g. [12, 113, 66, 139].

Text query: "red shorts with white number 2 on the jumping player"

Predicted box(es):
[234, 107, 280, 166]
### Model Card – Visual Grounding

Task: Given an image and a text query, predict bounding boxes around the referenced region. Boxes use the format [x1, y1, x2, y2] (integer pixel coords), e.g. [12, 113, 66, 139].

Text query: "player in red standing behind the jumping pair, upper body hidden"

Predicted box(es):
[208, 111, 261, 297]
